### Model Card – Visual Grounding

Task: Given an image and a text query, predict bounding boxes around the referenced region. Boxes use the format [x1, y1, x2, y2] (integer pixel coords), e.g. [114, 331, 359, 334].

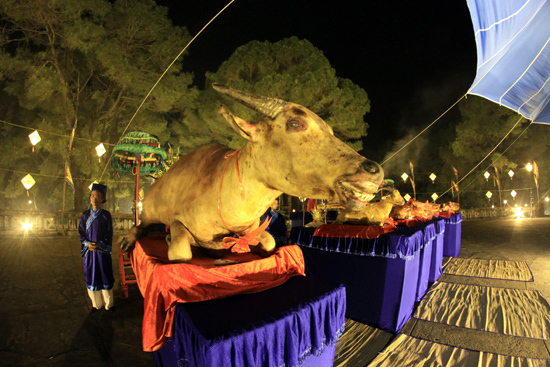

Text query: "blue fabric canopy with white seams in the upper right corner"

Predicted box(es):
[467, 0, 550, 124]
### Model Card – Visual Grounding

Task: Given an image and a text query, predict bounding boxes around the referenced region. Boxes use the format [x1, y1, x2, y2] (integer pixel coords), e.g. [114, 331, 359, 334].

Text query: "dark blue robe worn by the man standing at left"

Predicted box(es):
[78, 208, 115, 291]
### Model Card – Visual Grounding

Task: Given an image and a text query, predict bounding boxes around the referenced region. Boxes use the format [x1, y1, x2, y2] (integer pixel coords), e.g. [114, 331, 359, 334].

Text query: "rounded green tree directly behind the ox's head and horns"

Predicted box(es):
[173, 37, 370, 152]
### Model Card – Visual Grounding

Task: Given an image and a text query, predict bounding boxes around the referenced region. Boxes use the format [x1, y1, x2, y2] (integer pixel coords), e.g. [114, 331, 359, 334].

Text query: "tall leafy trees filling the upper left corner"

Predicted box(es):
[0, 0, 197, 210]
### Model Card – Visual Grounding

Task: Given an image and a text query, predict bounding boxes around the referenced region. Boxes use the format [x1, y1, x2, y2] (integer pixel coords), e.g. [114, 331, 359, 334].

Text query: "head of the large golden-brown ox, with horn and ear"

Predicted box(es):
[213, 84, 384, 208]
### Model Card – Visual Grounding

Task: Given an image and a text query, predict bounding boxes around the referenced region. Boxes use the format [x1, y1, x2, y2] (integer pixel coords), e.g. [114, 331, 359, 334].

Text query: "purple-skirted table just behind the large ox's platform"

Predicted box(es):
[292, 227, 424, 333]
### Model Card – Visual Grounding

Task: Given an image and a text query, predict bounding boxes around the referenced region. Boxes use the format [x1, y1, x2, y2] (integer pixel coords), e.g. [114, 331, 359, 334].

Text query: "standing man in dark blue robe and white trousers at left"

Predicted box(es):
[78, 184, 115, 312]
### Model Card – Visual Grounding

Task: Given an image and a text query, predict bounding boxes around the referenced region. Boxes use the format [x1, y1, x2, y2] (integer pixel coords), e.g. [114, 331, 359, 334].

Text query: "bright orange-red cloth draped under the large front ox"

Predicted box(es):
[130, 235, 305, 352]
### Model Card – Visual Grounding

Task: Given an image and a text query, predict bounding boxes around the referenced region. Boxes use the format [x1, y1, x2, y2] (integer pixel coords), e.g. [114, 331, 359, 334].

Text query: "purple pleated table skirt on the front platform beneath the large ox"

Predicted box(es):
[153, 276, 346, 367]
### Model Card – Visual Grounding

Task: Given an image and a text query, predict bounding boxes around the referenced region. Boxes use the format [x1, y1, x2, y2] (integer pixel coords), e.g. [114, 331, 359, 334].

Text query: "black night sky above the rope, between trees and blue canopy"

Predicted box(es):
[157, 0, 476, 159]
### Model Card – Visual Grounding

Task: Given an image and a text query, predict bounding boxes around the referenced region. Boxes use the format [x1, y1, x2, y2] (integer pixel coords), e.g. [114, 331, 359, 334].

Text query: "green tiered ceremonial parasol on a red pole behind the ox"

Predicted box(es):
[111, 131, 167, 225]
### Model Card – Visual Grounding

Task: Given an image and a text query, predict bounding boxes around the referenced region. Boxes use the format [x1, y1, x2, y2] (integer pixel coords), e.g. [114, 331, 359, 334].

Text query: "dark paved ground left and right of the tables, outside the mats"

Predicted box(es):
[0, 218, 550, 367]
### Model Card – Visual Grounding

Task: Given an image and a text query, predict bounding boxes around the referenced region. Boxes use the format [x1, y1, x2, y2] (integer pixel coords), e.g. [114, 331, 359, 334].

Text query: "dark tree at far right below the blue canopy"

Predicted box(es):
[444, 96, 550, 206]
